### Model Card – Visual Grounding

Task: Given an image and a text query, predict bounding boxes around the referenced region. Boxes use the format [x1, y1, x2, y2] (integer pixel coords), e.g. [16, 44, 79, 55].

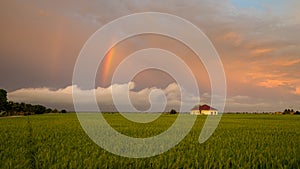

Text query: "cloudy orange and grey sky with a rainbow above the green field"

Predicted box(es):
[0, 0, 300, 112]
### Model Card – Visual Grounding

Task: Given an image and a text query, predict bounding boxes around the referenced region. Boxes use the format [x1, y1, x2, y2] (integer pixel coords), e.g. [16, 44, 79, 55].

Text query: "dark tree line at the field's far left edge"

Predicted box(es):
[0, 89, 67, 116]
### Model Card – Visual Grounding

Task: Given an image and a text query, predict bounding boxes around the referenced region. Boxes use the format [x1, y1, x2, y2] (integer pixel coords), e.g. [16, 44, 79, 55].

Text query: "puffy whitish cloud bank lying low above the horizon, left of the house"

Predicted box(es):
[8, 82, 202, 111]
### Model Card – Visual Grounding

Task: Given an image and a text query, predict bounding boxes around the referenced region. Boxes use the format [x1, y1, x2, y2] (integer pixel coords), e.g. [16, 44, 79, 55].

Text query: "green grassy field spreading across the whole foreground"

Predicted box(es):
[0, 114, 300, 168]
